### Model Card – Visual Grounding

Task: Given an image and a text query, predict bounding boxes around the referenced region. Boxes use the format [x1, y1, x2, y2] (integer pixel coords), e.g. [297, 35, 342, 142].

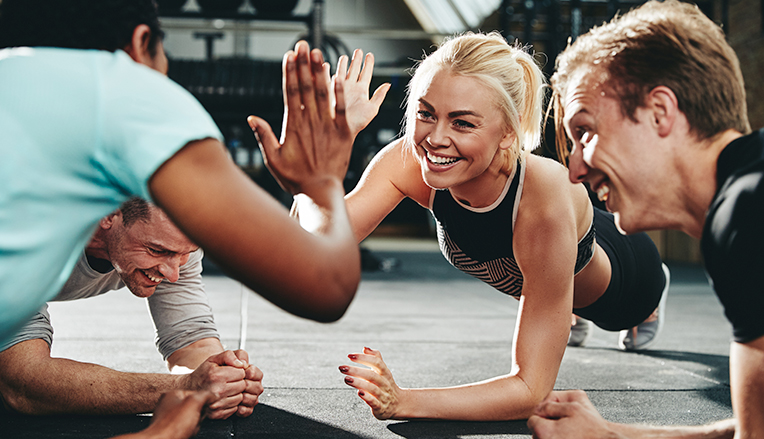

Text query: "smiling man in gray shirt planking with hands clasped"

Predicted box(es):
[0, 198, 263, 418]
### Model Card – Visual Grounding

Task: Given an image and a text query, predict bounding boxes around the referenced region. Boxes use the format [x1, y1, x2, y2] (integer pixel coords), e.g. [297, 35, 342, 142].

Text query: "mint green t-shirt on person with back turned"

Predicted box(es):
[0, 47, 222, 343]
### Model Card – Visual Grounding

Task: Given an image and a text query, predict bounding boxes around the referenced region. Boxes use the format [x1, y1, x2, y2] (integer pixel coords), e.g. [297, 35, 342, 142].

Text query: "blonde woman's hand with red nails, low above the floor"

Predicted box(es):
[340, 348, 401, 420]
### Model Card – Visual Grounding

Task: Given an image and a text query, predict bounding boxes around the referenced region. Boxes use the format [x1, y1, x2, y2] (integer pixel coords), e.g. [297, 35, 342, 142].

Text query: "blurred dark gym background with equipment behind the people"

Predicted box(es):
[157, 0, 764, 263]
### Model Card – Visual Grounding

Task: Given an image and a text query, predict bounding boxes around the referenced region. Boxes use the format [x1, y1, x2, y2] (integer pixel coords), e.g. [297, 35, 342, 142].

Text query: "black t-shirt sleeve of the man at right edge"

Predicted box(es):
[703, 171, 764, 343]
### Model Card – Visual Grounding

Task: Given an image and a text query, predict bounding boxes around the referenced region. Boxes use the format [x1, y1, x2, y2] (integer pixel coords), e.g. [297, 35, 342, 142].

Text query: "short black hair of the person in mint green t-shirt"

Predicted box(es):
[0, 0, 164, 56]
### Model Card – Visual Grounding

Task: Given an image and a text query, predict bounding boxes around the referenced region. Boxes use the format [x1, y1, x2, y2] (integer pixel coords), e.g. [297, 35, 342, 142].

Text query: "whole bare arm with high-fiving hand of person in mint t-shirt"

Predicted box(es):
[149, 42, 360, 321]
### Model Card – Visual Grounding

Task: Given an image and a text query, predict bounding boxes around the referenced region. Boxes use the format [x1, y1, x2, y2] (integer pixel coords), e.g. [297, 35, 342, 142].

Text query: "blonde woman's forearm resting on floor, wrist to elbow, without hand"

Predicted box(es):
[395, 376, 544, 421]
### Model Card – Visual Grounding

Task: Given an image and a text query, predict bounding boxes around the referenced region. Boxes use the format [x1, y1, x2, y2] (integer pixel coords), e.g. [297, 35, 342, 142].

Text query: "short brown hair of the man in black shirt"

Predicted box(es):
[551, 0, 751, 159]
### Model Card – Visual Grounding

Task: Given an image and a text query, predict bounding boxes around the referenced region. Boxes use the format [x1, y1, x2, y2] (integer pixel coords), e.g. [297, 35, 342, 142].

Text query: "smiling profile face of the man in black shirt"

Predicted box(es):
[562, 68, 666, 233]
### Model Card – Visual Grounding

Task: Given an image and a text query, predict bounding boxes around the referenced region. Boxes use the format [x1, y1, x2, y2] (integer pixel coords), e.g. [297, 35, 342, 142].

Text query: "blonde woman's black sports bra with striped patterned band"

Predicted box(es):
[430, 161, 596, 299]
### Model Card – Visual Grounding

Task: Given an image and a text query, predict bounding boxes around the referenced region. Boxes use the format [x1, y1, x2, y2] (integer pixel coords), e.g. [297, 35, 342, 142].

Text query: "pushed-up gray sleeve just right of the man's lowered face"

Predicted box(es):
[148, 249, 220, 360]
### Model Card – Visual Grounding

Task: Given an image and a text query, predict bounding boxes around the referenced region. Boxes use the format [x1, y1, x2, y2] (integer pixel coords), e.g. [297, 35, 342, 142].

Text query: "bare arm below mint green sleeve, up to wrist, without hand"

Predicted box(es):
[150, 142, 360, 321]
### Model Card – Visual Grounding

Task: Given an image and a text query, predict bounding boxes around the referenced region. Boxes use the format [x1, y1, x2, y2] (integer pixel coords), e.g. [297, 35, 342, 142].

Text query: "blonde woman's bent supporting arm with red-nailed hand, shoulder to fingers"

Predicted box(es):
[341, 159, 578, 421]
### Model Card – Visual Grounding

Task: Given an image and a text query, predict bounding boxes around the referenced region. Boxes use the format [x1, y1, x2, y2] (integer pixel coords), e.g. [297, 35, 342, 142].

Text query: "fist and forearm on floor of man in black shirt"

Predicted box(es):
[528, 390, 736, 439]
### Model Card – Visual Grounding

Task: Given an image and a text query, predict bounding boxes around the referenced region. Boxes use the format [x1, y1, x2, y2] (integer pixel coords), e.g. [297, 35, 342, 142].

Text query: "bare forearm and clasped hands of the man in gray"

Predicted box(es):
[0, 339, 262, 419]
